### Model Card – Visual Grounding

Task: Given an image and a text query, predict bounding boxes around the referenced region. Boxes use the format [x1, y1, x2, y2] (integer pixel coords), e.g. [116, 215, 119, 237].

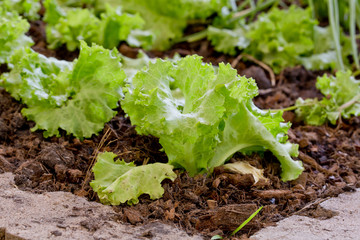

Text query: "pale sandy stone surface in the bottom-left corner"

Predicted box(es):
[0, 173, 202, 240]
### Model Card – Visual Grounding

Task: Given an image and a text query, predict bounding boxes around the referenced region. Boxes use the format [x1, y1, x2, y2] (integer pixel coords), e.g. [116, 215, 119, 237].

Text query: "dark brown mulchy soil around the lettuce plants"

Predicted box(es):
[0, 18, 360, 238]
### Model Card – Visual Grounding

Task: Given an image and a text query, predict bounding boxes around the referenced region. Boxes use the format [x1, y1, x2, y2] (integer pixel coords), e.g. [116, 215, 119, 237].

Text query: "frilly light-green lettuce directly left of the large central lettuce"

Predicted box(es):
[2, 42, 125, 139]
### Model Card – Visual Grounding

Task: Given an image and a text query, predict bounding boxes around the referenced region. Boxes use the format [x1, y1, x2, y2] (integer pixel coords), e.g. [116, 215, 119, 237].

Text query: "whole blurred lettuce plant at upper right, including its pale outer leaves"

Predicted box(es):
[207, 5, 351, 73]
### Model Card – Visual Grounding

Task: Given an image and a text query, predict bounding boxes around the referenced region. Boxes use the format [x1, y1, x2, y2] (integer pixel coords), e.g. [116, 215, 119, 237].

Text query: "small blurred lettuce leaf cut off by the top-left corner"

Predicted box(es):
[0, 0, 41, 20]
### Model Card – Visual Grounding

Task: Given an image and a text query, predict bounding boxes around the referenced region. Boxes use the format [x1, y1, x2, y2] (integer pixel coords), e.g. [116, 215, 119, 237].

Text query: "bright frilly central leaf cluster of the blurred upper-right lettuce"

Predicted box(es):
[246, 5, 317, 73]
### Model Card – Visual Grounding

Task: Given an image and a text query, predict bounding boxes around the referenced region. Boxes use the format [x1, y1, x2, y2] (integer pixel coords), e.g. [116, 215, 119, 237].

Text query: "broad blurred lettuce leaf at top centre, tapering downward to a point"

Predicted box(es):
[112, 0, 229, 50]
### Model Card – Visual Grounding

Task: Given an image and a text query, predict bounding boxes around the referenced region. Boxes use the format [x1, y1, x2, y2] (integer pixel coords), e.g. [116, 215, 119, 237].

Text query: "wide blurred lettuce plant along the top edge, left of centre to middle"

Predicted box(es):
[44, 0, 229, 50]
